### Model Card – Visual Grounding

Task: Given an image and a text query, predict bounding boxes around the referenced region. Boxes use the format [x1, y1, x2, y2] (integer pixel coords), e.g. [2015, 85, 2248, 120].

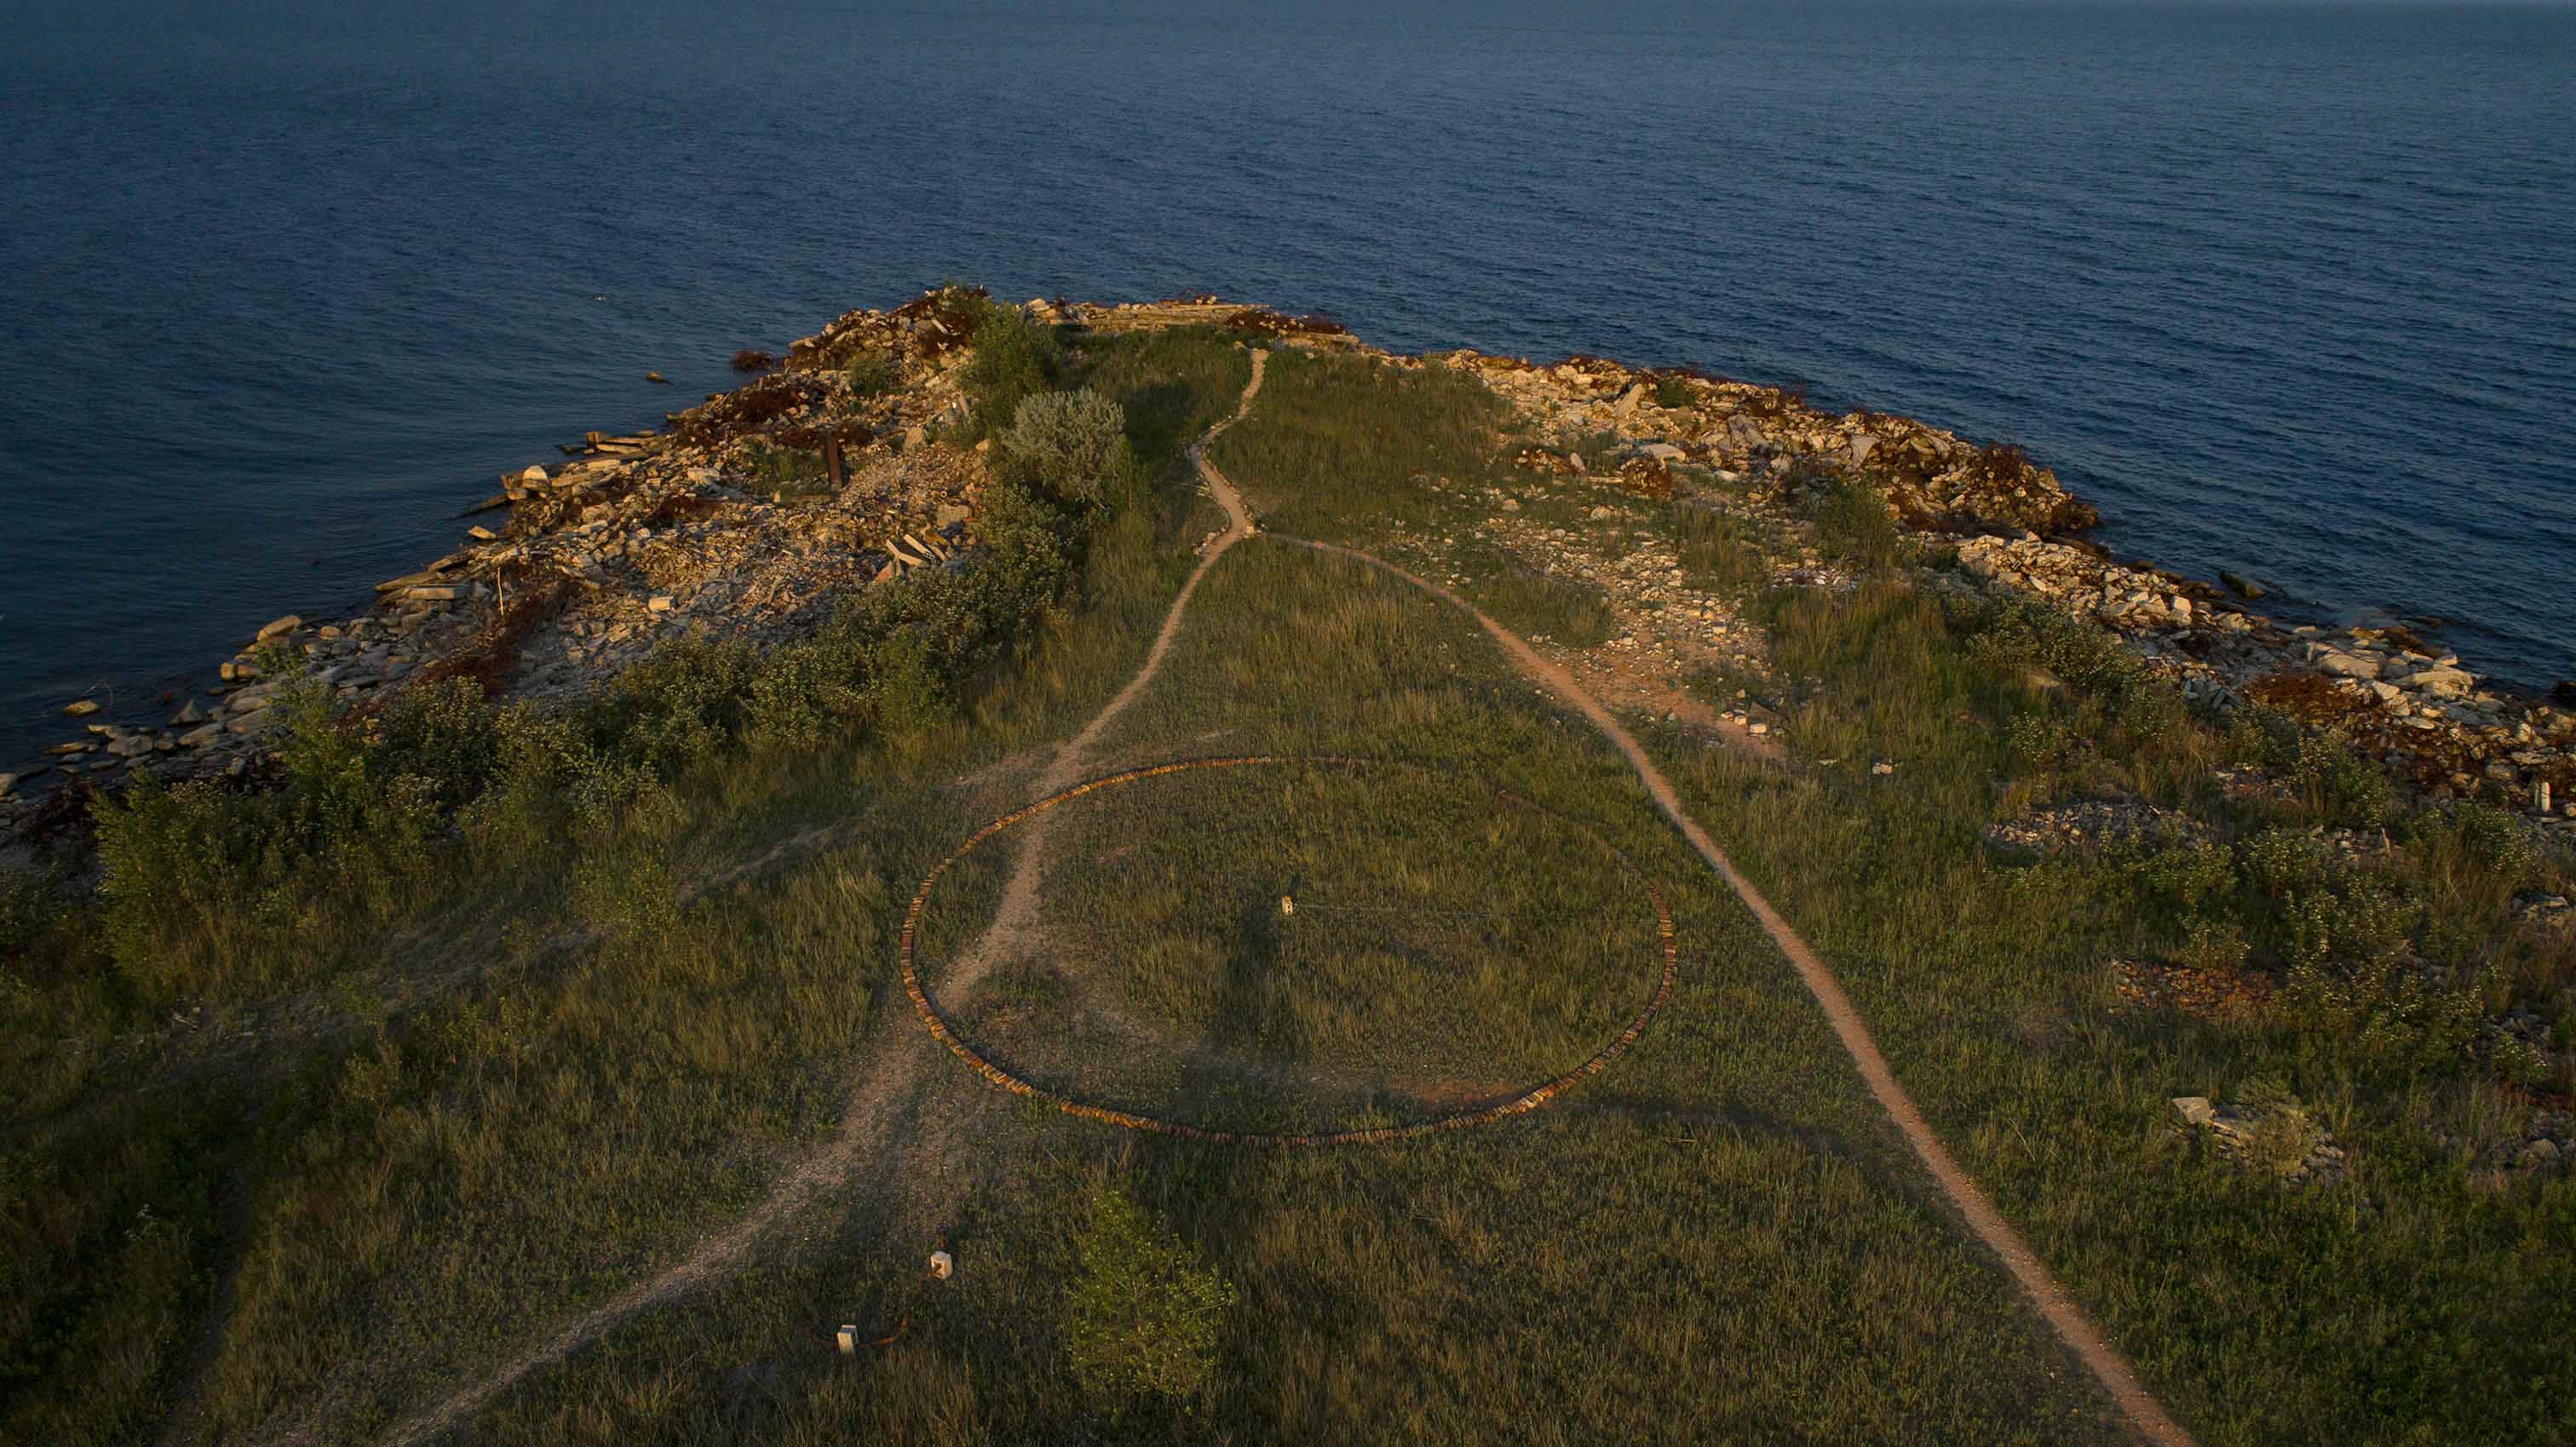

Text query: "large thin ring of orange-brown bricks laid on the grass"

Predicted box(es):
[899, 755, 1677, 1146]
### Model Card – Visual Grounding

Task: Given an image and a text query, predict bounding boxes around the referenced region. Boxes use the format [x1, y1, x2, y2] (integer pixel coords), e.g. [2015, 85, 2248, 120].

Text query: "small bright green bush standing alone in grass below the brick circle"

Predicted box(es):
[1064, 1187, 1233, 1416]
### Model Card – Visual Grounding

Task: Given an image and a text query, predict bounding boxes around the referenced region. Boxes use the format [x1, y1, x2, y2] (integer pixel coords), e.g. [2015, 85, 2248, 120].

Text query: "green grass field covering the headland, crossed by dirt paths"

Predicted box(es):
[0, 318, 2576, 1444]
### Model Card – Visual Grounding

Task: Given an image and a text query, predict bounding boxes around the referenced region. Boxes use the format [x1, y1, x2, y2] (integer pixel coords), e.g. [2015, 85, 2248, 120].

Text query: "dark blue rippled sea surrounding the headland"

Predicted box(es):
[0, 0, 2576, 770]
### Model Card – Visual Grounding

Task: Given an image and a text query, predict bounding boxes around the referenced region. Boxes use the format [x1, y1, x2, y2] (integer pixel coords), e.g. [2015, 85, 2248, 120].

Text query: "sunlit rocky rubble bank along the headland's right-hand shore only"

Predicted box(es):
[1424, 335, 2576, 834]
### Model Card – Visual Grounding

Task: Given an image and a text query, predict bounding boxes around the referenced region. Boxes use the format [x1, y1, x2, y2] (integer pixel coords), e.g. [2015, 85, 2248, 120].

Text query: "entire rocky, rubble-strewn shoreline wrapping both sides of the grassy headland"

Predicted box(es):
[0, 291, 2576, 837]
